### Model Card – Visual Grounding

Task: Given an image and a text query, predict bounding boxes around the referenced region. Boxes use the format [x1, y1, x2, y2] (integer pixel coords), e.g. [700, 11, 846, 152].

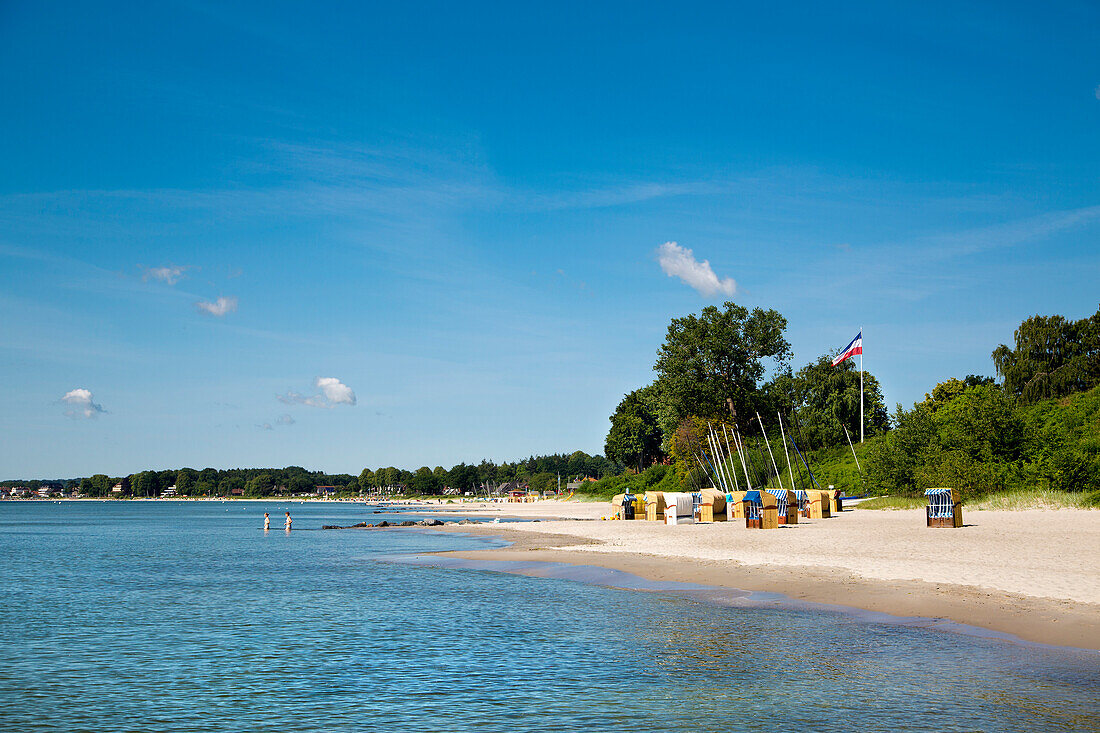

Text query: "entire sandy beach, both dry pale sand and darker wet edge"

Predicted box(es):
[429, 501, 1100, 649]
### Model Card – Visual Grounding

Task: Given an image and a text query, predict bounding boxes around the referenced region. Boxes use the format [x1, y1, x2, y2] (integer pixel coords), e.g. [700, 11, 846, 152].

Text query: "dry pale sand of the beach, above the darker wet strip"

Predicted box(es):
[442, 501, 1100, 604]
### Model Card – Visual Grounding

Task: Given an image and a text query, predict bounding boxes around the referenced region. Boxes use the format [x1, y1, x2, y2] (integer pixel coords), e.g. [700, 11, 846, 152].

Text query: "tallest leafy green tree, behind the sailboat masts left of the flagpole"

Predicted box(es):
[653, 302, 791, 436]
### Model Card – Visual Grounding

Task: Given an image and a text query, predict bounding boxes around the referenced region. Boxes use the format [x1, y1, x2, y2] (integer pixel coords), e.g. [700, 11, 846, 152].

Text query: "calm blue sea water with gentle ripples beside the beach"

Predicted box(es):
[0, 502, 1100, 732]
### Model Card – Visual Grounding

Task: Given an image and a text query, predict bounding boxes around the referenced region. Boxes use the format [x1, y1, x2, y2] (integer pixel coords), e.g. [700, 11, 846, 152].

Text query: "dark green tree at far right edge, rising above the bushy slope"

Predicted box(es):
[992, 308, 1100, 404]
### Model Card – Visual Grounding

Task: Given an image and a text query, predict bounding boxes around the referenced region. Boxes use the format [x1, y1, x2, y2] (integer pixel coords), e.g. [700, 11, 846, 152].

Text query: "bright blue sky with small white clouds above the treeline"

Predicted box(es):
[0, 2, 1100, 478]
